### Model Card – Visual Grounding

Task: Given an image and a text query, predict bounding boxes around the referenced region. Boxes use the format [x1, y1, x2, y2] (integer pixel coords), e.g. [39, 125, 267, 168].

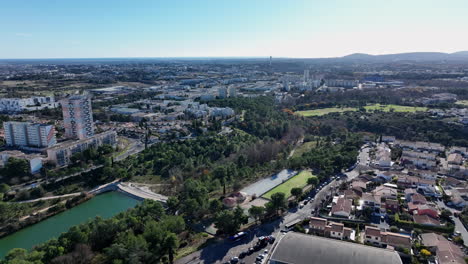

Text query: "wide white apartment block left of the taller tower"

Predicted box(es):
[3, 121, 57, 148]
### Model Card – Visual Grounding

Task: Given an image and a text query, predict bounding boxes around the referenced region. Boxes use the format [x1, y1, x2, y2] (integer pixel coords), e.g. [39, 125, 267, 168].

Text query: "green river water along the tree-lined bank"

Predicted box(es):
[0, 192, 139, 259]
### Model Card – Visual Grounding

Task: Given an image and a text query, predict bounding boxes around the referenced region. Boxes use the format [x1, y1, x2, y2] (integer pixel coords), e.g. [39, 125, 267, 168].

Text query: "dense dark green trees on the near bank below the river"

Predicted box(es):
[0, 201, 187, 264]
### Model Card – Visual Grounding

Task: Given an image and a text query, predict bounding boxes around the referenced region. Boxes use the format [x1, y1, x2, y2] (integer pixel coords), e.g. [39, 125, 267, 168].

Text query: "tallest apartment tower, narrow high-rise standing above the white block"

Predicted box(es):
[60, 95, 94, 139]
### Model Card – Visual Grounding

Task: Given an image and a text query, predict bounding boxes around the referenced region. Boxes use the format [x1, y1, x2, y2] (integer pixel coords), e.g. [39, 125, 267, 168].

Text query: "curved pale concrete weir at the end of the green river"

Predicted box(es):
[89, 181, 167, 203]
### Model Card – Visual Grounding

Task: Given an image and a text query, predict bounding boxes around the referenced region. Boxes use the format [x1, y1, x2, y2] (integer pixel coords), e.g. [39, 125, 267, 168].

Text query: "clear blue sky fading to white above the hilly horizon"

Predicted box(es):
[0, 0, 468, 58]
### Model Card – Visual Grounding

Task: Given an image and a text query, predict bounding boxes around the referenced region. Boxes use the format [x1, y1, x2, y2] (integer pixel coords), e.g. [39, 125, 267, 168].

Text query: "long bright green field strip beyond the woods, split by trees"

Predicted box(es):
[296, 104, 427, 117]
